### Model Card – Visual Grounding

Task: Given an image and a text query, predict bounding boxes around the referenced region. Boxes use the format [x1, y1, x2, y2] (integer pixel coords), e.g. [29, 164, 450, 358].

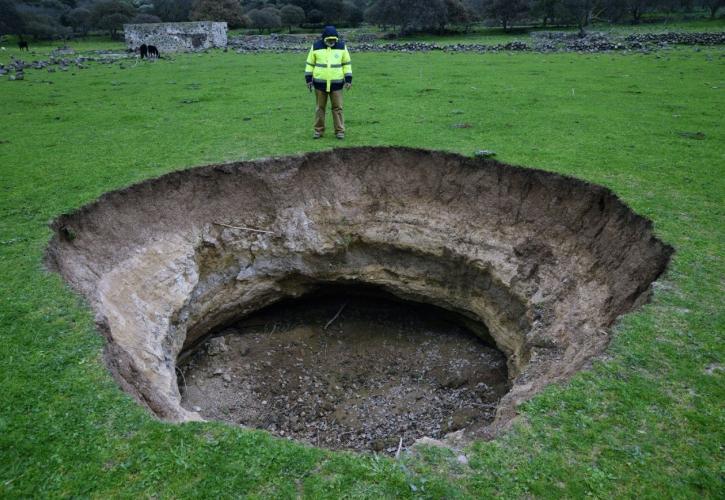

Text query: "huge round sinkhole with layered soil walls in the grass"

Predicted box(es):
[46, 148, 673, 452]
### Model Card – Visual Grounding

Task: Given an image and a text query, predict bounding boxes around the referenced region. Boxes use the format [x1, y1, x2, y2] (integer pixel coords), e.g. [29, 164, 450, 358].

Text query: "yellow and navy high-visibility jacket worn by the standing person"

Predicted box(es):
[305, 40, 352, 92]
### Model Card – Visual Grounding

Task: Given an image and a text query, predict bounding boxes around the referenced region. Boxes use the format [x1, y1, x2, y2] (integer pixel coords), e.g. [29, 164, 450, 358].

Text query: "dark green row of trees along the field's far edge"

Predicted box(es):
[0, 0, 725, 39]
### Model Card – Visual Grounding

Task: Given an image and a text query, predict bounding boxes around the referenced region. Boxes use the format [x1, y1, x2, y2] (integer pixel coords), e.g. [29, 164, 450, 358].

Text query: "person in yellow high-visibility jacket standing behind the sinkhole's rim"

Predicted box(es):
[305, 26, 352, 139]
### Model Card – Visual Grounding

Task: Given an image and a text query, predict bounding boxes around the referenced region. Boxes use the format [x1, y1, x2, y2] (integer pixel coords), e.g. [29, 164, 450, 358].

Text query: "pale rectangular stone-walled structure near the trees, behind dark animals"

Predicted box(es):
[123, 21, 227, 53]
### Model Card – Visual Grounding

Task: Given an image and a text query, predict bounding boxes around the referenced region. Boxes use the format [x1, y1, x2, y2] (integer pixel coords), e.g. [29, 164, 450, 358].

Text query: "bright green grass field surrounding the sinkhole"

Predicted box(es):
[0, 33, 725, 498]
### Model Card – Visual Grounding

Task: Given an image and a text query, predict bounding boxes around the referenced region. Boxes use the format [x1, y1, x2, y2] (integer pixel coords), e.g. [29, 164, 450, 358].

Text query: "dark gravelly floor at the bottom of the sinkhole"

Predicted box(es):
[179, 294, 509, 453]
